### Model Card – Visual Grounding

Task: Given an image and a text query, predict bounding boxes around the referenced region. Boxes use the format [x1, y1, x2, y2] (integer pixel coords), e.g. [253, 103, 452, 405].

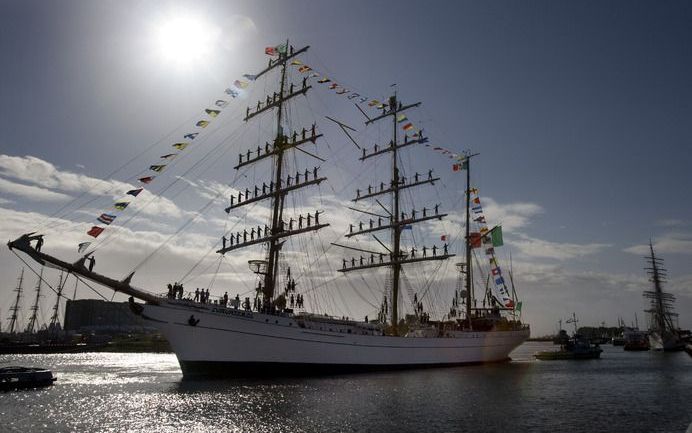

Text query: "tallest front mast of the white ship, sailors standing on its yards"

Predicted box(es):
[217, 41, 329, 307]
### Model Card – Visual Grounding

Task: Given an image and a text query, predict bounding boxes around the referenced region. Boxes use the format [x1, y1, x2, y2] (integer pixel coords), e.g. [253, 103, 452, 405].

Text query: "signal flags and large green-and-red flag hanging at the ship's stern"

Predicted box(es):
[469, 188, 510, 308]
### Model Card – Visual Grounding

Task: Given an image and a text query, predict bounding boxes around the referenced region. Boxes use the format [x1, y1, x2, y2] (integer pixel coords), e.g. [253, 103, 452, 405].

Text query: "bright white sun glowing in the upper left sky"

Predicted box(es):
[154, 13, 220, 65]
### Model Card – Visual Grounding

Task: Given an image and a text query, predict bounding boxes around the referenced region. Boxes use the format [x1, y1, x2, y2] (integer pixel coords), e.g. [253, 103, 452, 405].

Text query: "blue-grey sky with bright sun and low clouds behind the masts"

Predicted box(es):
[0, 0, 692, 335]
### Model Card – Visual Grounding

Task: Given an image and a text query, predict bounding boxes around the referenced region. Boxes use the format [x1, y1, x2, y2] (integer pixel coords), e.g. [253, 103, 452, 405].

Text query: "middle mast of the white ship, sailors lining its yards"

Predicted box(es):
[339, 93, 454, 335]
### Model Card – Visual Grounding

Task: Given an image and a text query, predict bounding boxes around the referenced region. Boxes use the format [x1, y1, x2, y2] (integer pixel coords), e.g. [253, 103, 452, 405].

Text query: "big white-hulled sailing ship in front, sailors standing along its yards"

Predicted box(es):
[8, 42, 530, 376]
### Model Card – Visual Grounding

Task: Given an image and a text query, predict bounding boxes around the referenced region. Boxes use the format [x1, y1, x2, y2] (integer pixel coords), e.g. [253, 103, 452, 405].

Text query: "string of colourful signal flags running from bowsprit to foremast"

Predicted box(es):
[77, 69, 260, 253]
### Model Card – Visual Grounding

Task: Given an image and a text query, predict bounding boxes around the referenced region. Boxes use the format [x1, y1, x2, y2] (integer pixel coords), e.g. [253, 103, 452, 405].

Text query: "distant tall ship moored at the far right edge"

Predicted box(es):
[644, 243, 685, 351]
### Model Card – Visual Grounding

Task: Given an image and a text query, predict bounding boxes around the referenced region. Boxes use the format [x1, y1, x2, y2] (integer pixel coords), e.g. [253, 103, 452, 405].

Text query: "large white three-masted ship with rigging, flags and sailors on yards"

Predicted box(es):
[8, 41, 530, 377]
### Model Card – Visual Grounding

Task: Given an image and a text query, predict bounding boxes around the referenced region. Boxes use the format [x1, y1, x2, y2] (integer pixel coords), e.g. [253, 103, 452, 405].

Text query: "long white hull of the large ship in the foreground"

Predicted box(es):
[141, 301, 529, 376]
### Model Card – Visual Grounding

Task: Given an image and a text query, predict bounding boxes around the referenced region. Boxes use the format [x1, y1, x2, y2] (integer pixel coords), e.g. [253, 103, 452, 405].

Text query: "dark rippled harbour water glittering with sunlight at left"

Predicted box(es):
[0, 343, 692, 433]
